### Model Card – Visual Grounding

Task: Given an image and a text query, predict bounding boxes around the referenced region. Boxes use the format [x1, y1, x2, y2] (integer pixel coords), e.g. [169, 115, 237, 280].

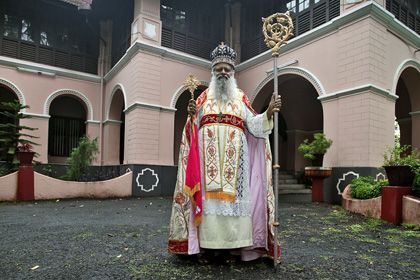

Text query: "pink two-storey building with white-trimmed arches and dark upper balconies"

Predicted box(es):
[0, 0, 420, 202]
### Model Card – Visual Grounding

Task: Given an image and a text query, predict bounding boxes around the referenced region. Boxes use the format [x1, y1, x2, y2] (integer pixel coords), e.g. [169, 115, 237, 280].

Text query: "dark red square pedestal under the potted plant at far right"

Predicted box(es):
[381, 186, 412, 225]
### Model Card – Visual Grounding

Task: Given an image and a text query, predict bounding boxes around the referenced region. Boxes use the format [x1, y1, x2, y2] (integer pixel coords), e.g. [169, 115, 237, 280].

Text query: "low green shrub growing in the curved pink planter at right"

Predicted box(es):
[350, 176, 388, 199]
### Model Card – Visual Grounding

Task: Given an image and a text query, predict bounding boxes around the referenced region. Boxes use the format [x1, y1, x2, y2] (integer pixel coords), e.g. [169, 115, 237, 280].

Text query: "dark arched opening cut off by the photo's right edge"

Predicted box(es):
[395, 67, 420, 149]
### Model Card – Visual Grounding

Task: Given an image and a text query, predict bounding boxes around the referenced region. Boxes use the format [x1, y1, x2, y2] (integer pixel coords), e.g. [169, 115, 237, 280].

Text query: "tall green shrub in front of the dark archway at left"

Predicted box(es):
[63, 136, 98, 181]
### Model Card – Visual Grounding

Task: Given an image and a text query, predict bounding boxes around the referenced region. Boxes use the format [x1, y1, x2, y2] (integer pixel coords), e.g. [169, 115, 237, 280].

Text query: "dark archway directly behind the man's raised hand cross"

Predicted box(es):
[174, 85, 207, 165]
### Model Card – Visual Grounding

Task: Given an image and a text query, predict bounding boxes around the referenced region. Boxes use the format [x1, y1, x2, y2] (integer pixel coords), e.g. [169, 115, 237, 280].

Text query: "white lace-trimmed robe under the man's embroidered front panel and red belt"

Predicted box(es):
[197, 89, 273, 249]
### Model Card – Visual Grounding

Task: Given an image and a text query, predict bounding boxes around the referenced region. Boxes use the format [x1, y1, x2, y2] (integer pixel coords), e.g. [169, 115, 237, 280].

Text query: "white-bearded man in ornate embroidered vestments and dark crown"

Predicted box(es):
[169, 43, 281, 260]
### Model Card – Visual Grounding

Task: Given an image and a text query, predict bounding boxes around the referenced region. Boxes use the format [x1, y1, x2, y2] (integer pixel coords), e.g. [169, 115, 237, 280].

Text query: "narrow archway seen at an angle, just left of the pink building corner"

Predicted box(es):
[104, 89, 125, 164]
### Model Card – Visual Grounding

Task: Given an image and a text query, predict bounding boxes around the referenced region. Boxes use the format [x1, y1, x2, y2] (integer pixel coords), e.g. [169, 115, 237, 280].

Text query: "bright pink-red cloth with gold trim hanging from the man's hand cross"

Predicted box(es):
[184, 122, 203, 226]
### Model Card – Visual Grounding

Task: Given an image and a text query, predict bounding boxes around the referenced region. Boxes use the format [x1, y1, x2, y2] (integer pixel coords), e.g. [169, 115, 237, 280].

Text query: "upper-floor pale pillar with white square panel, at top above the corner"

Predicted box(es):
[131, 0, 162, 45]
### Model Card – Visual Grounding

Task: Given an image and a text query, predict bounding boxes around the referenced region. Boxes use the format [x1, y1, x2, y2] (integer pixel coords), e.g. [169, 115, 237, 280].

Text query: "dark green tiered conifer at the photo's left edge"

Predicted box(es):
[0, 101, 38, 173]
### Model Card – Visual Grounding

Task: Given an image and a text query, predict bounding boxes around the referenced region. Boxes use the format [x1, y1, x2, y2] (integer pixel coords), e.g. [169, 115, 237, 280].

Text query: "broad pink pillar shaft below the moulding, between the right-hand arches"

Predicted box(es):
[321, 91, 395, 168]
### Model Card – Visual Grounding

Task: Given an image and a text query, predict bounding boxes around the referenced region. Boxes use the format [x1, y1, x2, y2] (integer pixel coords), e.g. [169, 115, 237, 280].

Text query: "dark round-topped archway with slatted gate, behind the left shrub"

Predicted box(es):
[48, 95, 86, 163]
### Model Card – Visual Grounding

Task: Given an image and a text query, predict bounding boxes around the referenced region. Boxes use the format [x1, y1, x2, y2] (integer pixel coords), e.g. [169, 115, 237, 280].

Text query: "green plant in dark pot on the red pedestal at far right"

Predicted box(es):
[383, 144, 420, 186]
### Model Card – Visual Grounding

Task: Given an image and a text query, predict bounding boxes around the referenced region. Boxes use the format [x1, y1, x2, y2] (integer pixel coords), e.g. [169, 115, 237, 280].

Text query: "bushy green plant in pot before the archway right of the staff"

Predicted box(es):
[298, 133, 332, 166]
